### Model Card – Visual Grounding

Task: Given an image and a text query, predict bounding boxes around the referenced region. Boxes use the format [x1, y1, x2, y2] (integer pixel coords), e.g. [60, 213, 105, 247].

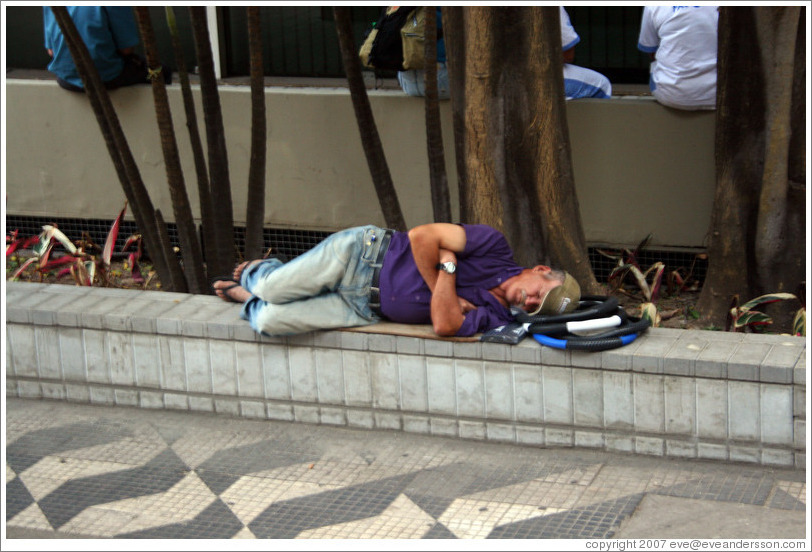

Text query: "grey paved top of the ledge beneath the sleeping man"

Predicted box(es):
[6, 282, 806, 385]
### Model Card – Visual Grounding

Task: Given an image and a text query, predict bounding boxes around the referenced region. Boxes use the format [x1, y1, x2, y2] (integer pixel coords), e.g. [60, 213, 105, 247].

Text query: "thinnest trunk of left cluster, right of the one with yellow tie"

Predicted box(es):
[166, 6, 215, 272]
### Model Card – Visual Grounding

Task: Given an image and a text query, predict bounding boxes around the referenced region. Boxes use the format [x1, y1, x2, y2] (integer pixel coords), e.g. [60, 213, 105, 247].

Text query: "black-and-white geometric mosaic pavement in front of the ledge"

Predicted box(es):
[5, 399, 806, 539]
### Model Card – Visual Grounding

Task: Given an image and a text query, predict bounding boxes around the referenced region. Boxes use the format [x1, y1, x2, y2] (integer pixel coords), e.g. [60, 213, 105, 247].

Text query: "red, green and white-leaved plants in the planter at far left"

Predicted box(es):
[6, 202, 144, 286]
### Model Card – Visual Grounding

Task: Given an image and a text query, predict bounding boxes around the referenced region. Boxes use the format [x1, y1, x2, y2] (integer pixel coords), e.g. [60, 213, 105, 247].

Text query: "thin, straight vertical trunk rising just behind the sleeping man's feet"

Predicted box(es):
[245, 7, 267, 259]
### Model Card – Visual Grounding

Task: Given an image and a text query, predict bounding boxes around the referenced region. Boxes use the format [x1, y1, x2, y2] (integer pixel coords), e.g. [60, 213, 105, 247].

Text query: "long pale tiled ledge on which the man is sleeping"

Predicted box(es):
[6, 282, 807, 468]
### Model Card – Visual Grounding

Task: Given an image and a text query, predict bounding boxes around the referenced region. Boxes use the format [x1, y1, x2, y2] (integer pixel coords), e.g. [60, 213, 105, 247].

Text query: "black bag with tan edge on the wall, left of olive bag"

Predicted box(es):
[359, 6, 416, 71]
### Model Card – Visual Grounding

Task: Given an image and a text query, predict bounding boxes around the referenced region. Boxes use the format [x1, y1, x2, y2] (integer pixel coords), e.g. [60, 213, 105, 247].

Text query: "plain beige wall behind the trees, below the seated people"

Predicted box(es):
[5, 79, 714, 247]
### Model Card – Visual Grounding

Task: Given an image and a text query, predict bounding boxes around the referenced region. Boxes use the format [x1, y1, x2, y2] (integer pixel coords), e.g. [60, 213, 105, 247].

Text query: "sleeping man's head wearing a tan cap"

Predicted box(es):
[505, 265, 581, 315]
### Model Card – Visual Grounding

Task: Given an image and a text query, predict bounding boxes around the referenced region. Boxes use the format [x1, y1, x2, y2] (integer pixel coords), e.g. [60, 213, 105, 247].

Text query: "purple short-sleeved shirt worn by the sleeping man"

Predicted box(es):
[379, 224, 523, 336]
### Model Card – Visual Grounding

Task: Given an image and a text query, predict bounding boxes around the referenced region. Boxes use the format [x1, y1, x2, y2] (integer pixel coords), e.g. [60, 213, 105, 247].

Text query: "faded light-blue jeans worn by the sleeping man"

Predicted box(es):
[240, 226, 384, 336]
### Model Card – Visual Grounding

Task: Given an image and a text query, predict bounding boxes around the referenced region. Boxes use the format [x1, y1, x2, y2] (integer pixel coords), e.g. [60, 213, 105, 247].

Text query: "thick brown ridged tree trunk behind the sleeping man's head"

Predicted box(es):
[444, 6, 600, 293]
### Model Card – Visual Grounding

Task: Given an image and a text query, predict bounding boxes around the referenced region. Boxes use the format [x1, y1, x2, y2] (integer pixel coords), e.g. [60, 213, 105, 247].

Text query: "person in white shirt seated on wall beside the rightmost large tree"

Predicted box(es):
[637, 6, 719, 110]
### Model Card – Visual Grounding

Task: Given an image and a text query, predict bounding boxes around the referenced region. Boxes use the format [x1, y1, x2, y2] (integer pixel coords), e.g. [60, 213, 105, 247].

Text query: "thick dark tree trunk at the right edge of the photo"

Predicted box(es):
[697, 7, 806, 327]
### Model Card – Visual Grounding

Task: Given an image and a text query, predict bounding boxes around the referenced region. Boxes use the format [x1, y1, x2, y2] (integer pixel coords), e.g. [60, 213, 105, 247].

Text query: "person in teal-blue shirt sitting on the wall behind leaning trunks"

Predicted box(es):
[43, 6, 171, 92]
